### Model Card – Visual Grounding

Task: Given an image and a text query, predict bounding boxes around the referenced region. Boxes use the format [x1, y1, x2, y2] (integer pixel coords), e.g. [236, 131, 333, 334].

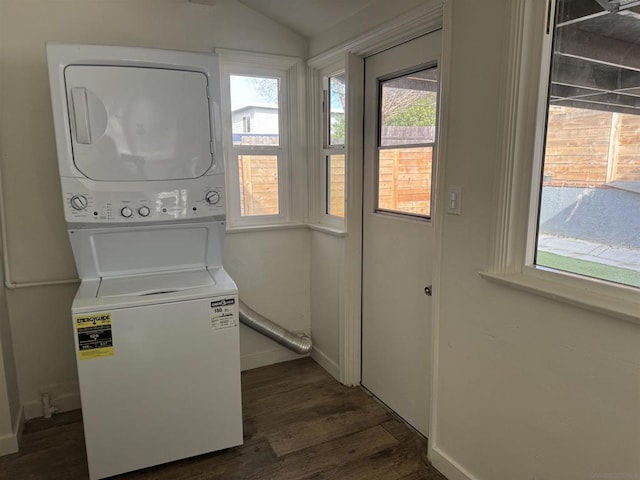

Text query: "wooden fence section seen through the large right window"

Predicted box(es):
[544, 106, 640, 188]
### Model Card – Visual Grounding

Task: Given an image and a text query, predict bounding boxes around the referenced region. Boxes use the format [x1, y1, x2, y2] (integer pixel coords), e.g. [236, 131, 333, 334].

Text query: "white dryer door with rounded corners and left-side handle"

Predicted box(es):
[65, 65, 214, 181]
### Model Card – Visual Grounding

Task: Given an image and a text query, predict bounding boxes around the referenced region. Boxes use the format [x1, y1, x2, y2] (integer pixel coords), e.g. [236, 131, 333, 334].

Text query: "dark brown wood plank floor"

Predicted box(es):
[0, 358, 446, 480]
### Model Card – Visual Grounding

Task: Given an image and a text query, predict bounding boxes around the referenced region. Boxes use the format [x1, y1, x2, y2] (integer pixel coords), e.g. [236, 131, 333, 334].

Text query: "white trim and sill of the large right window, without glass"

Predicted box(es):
[480, 0, 640, 323]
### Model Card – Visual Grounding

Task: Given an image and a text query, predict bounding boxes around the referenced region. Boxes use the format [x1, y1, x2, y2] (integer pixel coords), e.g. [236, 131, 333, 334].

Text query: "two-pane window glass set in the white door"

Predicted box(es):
[377, 67, 438, 218]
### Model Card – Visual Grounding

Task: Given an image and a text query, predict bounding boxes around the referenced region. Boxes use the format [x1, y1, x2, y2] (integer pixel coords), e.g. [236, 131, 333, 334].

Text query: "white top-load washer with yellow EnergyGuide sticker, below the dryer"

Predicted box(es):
[72, 268, 242, 479]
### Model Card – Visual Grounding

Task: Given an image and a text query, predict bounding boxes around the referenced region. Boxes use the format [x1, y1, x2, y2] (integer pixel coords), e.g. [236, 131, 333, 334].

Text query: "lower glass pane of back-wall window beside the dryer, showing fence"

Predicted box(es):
[238, 155, 280, 216]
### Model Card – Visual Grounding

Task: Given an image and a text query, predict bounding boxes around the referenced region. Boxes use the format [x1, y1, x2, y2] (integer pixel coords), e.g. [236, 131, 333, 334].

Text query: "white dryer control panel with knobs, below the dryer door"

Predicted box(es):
[62, 174, 226, 224]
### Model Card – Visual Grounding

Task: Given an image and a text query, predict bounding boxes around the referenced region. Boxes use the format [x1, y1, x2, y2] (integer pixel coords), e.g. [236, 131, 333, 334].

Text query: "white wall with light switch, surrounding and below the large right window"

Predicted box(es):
[430, 0, 640, 480]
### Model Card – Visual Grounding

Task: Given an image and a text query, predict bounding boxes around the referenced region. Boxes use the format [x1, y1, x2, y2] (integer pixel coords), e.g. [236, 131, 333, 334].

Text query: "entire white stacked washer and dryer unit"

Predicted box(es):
[47, 44, 242, 480]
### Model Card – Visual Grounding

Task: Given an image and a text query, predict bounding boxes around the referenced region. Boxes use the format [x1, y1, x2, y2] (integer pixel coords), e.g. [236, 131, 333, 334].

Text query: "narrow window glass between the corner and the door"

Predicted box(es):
[323, 72, 346, 219]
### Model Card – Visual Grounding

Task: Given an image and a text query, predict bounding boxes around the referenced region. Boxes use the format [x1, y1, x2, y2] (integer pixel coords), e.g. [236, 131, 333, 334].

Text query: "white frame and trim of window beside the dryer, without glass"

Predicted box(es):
[215, 49, 306, 230]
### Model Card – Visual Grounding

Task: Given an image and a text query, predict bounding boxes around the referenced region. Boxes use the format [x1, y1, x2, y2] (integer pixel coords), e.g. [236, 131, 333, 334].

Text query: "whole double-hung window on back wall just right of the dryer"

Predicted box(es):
[218, 50, 304, 228]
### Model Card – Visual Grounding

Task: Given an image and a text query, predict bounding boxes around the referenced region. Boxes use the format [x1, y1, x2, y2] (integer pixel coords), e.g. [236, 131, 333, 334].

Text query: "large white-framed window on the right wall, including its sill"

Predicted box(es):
[483, 0, 640, 321]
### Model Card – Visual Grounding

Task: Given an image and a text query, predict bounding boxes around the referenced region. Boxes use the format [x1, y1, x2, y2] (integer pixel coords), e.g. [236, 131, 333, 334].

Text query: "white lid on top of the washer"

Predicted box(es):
[97, 269, 216, 298]
